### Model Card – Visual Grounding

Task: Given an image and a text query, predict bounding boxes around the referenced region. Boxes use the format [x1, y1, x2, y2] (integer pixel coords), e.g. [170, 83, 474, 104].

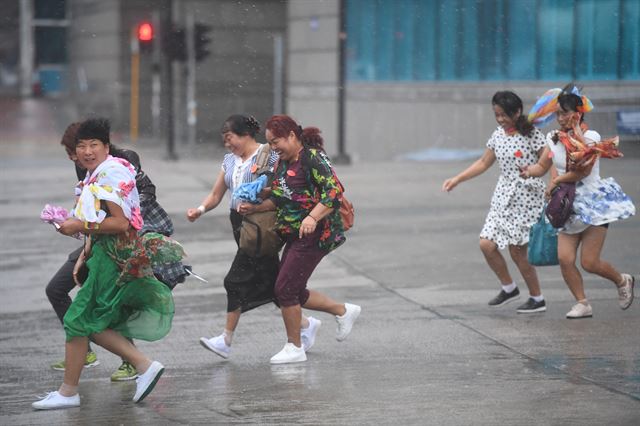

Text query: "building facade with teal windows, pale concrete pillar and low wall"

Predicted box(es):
[287, 0, 640, 161]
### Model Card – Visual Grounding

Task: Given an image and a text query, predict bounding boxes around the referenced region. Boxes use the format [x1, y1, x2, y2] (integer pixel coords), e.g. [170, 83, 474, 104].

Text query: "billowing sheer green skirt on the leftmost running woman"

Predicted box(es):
[64, 237, 174, 341]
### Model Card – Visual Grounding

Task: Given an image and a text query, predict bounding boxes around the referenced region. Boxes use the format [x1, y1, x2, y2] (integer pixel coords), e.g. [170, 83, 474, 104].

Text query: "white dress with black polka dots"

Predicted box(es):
[480, 127, 545, 249]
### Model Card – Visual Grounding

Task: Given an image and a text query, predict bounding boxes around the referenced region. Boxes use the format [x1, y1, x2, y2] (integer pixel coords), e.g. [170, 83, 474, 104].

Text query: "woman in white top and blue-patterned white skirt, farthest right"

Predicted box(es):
[522, 85, 635, 319]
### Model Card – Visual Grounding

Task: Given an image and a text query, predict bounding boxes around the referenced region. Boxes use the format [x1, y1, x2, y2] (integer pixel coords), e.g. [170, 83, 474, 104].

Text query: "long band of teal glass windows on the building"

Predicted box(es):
[346, 0, 640, 81]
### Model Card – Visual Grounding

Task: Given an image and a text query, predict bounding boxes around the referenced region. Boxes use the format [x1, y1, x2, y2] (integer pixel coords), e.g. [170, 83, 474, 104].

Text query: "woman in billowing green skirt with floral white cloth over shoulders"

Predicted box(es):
[32, 119, 184, 410]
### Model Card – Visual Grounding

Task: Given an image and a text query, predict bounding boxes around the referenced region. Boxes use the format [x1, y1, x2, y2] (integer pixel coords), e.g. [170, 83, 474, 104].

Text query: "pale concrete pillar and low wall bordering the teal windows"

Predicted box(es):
[286, 0, 640, 161]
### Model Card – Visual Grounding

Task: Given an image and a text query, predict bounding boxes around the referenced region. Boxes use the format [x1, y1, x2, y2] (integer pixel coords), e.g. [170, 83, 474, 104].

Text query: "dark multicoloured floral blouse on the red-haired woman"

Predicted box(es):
[271, 148, 345, 252]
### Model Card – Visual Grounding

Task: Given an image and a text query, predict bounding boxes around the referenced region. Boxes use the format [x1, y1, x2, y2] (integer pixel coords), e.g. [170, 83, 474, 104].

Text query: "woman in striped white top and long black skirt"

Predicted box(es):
[187, 114, 321, 359]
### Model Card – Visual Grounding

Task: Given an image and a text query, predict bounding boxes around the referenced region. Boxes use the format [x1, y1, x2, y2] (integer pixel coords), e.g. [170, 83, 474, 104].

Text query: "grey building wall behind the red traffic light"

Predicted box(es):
[69, 0, 286, 147]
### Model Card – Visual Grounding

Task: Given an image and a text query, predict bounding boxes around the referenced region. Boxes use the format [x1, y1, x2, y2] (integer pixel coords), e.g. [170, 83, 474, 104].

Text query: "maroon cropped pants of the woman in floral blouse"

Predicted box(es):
[274, 227, 327, 307]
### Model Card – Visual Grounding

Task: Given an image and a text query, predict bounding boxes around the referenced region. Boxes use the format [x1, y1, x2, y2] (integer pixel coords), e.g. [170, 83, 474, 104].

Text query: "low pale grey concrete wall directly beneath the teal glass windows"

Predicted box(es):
[345, 82, 640, 160]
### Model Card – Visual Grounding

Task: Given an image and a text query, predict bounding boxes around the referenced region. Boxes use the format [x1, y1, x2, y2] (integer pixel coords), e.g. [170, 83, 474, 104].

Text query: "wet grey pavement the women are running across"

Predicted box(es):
[0, 98, 640, 425]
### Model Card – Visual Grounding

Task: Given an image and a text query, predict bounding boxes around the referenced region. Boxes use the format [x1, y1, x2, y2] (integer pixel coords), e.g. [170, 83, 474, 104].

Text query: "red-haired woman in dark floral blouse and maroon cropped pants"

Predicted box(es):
[239, 115, 360, 364]
